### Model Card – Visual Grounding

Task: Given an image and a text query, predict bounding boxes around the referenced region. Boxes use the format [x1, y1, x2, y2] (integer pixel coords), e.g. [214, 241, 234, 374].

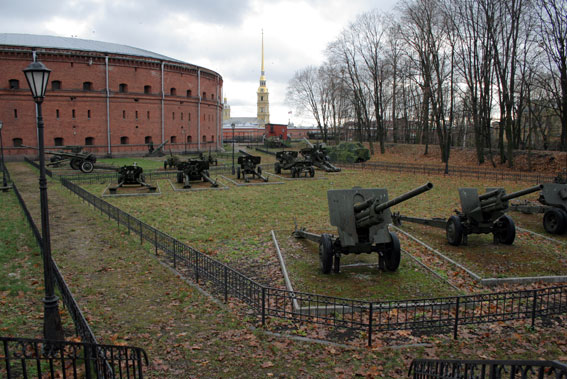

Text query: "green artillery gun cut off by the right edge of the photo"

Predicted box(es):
[510, 174, 567, 234]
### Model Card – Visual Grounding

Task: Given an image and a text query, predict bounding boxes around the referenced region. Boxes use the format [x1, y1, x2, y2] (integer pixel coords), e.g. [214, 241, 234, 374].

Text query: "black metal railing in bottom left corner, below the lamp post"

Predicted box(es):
[0, 337, 148, 379]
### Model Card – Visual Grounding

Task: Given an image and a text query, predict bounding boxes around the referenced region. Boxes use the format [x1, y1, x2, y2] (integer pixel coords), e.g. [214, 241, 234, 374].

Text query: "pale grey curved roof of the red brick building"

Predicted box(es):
[0, 33, 186, 63]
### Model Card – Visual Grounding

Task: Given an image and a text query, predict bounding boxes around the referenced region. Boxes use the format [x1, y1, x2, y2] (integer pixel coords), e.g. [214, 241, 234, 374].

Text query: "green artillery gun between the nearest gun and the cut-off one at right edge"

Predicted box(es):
[393, 185, 542, 246]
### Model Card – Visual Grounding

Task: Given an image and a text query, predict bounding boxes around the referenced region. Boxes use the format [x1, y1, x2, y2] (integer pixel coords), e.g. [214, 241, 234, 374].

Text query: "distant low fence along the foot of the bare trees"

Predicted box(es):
[338, 162, 554, 183]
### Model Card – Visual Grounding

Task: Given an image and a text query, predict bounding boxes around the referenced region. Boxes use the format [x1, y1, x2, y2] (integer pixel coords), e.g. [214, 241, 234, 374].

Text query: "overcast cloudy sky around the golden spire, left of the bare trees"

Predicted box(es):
[0, 0, 396, 125]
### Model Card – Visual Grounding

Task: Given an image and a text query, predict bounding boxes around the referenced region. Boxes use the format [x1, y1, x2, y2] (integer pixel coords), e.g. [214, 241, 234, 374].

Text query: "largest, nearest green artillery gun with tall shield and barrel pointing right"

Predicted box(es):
[293, 183, 433, 274]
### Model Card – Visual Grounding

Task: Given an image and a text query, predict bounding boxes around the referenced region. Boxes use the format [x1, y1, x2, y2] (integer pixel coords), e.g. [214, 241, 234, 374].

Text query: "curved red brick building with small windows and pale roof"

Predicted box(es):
[0, 33, 223, 156]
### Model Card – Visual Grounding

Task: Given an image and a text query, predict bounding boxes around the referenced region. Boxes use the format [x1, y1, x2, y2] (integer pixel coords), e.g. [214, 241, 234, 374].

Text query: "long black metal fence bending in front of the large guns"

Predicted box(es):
[56, 172, 567, 345]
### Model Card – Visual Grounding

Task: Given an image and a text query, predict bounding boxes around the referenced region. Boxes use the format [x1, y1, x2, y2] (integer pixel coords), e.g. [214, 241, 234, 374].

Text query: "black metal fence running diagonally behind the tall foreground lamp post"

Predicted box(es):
[6, 166, 149, 375]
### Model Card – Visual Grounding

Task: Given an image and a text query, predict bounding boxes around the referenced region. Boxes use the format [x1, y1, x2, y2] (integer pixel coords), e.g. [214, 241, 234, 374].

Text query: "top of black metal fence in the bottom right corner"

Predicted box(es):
[408, 359, 567, 379]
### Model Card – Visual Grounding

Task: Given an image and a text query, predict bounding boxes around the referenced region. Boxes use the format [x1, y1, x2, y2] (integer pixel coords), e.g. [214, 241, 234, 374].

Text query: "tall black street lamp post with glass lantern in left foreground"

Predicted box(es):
[24, 62, 64, 340]
